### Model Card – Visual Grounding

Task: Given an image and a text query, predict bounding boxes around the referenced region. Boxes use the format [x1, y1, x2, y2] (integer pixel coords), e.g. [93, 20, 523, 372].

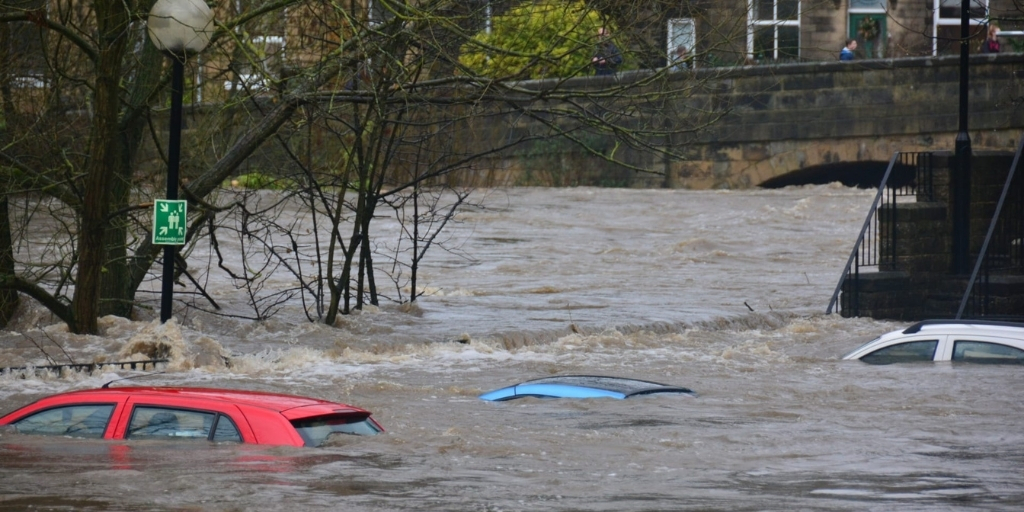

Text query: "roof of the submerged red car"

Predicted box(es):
[48, 386, 366, 413]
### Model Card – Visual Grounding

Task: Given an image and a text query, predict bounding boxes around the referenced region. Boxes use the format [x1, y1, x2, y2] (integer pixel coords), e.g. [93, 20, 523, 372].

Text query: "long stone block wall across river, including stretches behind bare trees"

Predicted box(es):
[146, 53, 1024, 189]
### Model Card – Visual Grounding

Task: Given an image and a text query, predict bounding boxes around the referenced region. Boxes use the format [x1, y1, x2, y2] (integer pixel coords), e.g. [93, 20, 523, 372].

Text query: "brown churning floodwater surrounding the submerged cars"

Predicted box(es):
[0, 185, 1024, 512]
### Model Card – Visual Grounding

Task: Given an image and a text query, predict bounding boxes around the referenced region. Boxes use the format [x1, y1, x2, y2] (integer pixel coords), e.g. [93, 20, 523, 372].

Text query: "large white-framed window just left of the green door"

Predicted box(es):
[746, 0, 800, 60]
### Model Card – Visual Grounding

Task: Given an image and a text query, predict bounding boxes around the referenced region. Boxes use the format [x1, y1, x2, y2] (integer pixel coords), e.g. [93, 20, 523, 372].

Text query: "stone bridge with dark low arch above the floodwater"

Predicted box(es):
[477, 53, 1024, 188]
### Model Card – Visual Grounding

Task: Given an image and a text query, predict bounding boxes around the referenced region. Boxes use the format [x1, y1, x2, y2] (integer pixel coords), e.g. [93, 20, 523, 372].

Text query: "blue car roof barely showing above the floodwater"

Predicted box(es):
[480, 375, 696, 401]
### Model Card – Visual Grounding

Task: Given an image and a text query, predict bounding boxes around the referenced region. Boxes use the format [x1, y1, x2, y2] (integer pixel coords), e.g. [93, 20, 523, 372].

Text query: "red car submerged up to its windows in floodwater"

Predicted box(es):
[0, 387, 384, 446]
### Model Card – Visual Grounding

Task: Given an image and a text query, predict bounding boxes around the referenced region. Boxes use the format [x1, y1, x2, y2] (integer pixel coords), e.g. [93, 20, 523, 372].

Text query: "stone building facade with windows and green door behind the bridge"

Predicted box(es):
[664, 0, 1024, 66]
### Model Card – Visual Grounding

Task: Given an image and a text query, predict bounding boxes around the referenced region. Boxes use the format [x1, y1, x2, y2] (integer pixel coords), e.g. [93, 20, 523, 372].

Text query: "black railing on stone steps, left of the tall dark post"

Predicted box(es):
[825, 152, 935, 316]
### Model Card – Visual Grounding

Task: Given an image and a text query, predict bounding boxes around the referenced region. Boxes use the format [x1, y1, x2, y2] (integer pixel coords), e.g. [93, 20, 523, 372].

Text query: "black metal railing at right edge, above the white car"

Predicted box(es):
[956, 137, 1024, 318]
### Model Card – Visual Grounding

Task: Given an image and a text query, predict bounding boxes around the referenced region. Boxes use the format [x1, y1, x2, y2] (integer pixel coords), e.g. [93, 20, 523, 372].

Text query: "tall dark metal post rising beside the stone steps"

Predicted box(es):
[950, 0, 971, 273]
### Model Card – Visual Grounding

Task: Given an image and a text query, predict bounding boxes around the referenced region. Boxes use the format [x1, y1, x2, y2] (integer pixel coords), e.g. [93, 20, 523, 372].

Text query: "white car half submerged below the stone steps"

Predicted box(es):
[843, 319, 1024, 365]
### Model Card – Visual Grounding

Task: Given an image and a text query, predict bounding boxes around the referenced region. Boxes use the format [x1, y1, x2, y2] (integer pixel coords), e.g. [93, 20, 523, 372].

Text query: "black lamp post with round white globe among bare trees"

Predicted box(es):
[146, 0, 213, 323]
